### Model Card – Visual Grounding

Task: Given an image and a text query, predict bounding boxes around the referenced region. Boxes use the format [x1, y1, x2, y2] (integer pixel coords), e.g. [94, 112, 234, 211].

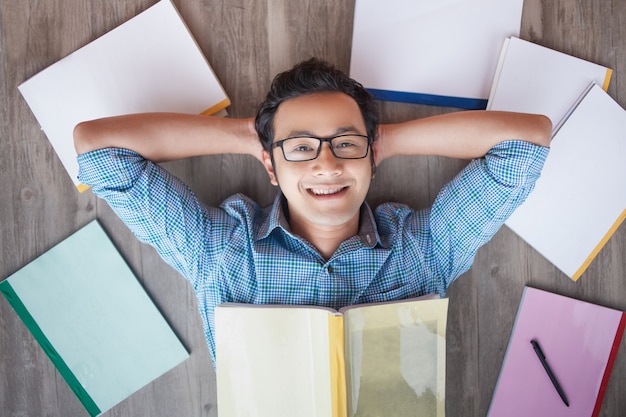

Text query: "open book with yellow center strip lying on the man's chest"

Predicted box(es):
[215, 296, 448, 417]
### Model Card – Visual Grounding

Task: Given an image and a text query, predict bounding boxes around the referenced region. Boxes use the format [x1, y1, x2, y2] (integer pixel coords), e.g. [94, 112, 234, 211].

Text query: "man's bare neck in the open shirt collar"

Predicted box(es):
[290, 215, 359, 260]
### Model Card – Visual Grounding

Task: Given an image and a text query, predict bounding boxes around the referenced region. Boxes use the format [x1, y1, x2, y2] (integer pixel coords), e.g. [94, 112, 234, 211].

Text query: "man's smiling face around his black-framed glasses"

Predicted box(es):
[264, 92, 372, 236]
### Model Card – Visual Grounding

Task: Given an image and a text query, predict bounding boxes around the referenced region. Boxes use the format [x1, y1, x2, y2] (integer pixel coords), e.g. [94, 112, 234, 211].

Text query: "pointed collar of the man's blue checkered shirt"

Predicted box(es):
[254, 192, 381, 248]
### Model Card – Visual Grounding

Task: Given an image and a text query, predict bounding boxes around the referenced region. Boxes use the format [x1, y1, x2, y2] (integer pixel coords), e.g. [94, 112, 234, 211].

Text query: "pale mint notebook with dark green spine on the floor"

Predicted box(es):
[0, 221, 189, 416]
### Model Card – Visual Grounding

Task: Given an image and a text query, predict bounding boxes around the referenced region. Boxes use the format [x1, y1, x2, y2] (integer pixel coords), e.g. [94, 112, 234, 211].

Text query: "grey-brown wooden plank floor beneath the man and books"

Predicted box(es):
[0, 0, 626, 417]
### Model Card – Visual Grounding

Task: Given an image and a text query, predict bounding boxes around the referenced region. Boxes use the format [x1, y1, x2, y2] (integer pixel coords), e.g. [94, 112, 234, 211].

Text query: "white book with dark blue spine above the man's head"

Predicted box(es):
[350, 0, 523, 109]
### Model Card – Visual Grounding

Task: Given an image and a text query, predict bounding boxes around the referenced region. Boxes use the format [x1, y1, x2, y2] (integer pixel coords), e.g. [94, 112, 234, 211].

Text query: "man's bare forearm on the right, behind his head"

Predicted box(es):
[374, 111, 552, 163]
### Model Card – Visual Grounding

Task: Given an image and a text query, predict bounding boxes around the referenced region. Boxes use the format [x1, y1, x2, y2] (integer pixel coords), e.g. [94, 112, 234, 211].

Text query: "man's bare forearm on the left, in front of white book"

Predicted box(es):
[74, 113, 263, 162]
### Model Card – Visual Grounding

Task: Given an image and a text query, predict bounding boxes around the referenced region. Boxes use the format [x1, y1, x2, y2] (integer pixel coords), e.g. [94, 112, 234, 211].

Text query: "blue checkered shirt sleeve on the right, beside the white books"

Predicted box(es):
[429, 141, 549, 293]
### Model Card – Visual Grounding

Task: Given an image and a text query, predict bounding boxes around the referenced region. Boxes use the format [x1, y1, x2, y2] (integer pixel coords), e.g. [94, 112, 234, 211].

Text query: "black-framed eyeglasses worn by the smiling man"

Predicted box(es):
[272, 134, 372, 162]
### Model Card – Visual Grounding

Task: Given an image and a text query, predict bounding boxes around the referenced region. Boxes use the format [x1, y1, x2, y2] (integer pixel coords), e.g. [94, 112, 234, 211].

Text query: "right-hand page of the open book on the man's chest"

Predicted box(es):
[344, 299, 448, 417]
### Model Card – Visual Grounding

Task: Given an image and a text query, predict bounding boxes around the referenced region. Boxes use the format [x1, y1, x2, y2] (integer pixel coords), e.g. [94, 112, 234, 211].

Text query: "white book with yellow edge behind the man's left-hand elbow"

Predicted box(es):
[18, 0, 230, 191]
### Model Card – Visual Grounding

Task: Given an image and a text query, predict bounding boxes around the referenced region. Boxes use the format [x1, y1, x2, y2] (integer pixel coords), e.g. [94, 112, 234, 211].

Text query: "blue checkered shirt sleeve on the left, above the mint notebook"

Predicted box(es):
[78, 148, 227, 285]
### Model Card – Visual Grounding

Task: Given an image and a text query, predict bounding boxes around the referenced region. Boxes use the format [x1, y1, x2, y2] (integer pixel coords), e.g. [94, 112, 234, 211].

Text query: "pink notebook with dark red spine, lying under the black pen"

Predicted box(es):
[488, 287, 626, 417]
